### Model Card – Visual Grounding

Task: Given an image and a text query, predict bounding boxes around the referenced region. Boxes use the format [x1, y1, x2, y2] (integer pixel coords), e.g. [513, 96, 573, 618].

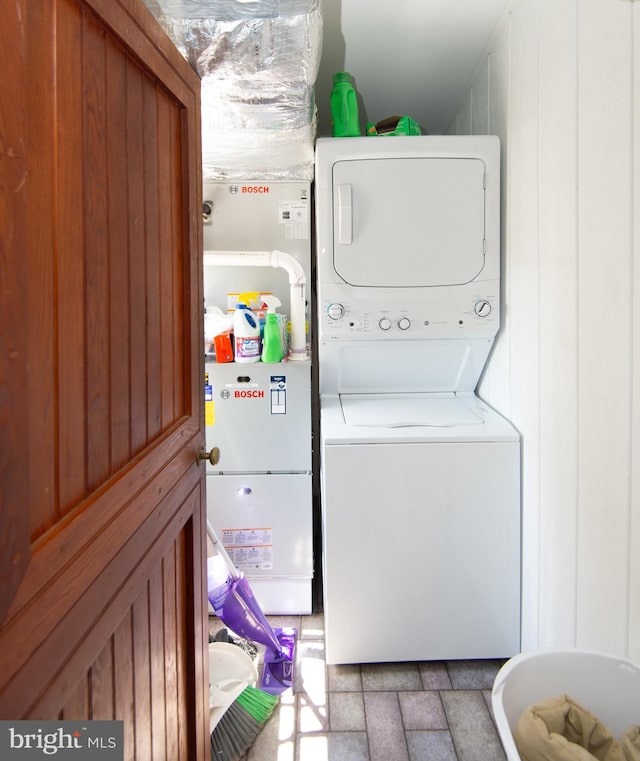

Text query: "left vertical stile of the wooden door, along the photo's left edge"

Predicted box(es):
[0, 0, 30, 625]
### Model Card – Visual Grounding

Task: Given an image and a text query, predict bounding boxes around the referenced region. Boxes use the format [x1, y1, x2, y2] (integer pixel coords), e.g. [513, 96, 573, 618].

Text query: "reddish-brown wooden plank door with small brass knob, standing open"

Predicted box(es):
[0, 0, 209, 761]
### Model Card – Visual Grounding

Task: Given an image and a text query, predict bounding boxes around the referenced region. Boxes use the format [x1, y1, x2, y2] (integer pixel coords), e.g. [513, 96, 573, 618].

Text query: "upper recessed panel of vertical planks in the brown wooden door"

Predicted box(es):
[22, 0, 189, 524]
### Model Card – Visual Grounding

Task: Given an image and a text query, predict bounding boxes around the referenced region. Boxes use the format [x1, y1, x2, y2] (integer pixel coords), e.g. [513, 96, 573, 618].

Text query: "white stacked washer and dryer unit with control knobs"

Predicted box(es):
[316, 136, 520, 664]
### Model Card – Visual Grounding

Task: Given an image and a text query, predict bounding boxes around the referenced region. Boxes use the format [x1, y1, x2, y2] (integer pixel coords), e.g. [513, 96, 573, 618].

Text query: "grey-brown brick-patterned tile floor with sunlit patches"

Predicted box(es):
[210, 614, 505, 761]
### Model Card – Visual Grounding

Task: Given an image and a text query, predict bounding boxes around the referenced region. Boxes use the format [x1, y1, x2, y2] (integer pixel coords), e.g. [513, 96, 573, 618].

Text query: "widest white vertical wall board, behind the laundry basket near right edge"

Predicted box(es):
[577, 0, 632, 652]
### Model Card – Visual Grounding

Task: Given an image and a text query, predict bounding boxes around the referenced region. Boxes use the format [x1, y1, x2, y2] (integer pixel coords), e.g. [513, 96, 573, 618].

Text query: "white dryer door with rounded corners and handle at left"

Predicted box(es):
[333, 156, 485, 288]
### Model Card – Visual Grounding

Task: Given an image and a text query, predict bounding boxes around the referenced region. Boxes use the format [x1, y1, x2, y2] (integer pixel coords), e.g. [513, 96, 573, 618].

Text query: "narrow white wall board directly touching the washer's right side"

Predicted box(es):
[505, 0, 540, 647]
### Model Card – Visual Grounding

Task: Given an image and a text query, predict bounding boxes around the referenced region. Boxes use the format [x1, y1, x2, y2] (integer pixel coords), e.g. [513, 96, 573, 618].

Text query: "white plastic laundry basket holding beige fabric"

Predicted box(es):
[491, 650, 640, 761]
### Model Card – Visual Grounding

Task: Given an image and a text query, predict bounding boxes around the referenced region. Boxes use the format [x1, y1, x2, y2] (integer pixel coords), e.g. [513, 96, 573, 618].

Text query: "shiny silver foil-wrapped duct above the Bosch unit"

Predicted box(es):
[147, 0, 322, 181]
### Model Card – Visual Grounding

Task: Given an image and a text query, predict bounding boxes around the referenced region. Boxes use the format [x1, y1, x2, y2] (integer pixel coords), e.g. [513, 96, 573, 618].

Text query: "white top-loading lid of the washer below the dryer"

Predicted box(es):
[340, 393, 484, 428]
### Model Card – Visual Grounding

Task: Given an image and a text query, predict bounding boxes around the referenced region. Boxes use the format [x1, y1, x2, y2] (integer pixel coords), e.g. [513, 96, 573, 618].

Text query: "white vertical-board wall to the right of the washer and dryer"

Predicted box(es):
[449, 0, 640, 662]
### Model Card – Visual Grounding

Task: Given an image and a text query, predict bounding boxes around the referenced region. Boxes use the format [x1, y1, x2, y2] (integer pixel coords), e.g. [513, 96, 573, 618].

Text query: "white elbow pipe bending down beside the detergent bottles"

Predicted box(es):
[204, 250, 307, 360]
